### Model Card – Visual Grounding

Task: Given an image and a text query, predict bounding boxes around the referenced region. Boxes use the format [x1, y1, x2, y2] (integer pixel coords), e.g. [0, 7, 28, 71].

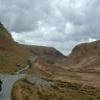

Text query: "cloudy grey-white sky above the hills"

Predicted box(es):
[0, 0, 100, 55]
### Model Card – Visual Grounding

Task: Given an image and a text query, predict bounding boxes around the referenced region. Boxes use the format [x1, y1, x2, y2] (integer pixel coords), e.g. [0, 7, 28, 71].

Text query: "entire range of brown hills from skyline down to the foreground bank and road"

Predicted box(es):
[0, 21, 100, 87]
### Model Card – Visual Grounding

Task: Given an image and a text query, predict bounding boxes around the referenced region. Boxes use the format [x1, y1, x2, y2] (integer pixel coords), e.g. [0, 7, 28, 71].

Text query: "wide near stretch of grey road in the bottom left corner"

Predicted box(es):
[0, 74, 23, 100]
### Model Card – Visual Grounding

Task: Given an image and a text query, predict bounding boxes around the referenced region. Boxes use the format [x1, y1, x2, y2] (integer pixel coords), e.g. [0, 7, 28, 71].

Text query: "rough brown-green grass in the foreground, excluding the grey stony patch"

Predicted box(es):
[12, 79, 100, 100]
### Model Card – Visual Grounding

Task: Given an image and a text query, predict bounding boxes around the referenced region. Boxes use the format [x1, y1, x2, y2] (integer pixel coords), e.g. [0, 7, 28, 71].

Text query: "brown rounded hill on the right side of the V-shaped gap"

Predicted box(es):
[67, 40, 100, 72]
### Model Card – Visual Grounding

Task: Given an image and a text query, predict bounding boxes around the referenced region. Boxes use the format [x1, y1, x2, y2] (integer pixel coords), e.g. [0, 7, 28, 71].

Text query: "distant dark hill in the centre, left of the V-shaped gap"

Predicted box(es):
[24, 45, 65, 64]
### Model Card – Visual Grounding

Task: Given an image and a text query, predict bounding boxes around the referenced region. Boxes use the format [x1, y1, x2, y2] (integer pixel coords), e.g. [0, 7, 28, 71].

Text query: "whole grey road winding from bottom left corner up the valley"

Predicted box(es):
[0, 57, 36, 100]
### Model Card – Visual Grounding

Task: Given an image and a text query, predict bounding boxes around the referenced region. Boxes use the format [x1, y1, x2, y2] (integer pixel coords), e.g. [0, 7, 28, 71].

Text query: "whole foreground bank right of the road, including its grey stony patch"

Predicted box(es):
[11, 77, 100, 100]
